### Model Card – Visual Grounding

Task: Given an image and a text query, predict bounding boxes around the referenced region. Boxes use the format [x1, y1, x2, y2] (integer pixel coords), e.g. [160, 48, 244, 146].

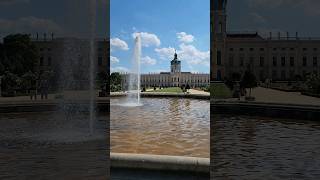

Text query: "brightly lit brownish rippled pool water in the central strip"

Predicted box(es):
[110, 98, 210, 158]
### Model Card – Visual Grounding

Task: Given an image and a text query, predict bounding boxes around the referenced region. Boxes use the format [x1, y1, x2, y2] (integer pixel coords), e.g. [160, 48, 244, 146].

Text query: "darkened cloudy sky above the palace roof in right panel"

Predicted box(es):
[227, 0, 320, 37]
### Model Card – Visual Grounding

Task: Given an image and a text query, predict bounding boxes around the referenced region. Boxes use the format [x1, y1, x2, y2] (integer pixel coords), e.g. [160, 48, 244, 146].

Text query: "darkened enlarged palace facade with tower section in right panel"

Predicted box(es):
[211, 0, 320, 81]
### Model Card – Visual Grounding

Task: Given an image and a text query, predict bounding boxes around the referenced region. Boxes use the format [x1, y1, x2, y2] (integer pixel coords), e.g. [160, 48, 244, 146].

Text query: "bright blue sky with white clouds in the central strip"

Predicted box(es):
[110, 0, 210, 73]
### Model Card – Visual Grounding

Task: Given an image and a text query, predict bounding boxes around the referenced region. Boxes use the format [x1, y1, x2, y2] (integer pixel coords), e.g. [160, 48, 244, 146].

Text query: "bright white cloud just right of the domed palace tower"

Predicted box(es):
[177, 44, 210, 67]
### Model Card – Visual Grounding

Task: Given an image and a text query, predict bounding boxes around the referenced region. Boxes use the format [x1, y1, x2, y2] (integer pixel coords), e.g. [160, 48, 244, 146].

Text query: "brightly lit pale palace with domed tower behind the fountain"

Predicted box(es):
[122, 53, 210, 89]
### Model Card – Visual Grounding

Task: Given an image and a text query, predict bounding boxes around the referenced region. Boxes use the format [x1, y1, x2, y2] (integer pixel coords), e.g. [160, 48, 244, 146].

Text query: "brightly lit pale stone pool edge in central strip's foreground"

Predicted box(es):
[110, 153, 210, 173]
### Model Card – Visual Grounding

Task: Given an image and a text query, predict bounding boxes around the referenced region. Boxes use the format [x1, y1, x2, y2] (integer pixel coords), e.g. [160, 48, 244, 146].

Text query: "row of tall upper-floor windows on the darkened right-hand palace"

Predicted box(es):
[228, 56, 318, 67]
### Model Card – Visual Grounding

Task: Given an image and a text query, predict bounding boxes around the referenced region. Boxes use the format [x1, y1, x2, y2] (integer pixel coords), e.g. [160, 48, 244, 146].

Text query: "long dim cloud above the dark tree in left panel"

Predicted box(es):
[0, 16, 64, 34]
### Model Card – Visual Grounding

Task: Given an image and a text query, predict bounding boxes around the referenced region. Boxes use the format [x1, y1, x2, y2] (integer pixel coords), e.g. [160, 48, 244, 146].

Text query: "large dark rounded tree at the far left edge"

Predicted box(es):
[0, 34, 38, 77]
